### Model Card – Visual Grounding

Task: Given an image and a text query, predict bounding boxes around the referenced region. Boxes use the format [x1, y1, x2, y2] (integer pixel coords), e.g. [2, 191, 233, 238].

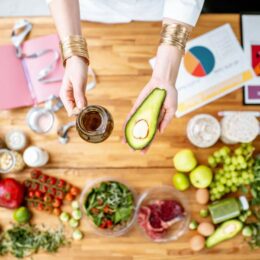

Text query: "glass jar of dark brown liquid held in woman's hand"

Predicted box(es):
[76, 106, 114, 143]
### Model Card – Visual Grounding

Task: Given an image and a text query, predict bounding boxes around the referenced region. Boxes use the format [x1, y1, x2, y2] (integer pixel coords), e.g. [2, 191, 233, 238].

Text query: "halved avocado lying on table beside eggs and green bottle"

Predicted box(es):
[206, 220, 243, 248]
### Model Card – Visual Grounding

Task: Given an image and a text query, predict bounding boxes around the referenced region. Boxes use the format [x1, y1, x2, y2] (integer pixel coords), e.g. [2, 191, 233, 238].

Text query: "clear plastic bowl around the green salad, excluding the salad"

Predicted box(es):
[80, 177, 137, 237]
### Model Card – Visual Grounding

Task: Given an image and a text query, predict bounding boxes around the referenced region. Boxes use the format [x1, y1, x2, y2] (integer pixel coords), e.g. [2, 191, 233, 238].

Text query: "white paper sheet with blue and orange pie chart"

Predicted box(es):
[150, 24, 255, 117]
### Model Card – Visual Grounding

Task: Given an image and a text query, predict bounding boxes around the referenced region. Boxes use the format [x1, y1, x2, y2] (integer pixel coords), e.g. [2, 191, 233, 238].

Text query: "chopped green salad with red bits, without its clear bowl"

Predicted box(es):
[85, 181, 134, 229]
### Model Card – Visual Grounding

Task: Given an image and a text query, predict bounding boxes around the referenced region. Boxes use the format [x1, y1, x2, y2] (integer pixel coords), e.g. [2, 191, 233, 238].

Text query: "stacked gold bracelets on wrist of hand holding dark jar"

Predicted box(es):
[60, 35, 89, 66]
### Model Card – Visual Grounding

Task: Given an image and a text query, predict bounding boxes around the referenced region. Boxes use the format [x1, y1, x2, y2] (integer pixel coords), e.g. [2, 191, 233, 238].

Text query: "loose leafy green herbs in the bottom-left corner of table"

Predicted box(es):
[0, 225, 67, 258]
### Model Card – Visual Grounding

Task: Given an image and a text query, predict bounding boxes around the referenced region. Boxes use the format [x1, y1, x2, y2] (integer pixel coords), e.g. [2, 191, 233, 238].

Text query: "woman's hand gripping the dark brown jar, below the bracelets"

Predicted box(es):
[60, 56, 88, 116]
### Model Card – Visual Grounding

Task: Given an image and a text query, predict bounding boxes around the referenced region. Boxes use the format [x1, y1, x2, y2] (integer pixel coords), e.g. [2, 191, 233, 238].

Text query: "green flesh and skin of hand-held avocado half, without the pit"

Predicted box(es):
[125, 88, 166, 150]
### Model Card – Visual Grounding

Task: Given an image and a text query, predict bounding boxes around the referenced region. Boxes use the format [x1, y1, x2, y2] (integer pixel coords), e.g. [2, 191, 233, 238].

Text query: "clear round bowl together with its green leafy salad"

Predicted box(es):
[80, 178, 136, 236]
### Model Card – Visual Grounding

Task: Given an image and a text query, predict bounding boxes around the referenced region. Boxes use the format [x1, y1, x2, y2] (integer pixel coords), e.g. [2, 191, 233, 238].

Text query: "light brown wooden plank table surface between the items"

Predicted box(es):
[0, 15, 260, 260]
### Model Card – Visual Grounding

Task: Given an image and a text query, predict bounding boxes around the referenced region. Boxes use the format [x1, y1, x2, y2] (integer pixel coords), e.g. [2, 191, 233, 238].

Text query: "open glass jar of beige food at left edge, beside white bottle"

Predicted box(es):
[0, 149, 25, 174]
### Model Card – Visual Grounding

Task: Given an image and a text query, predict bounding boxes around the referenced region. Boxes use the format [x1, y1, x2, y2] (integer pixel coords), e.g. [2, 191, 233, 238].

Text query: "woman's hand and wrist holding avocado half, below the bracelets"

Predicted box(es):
[125, 45, 181, 152]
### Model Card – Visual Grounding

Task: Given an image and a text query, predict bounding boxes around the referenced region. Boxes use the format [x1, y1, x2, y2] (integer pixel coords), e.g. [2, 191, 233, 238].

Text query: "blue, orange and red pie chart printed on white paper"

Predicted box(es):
[184, 46, 215, 77]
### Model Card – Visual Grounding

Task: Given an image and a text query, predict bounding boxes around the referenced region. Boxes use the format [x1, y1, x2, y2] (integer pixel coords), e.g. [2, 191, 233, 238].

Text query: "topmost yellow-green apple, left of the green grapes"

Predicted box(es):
[173, 149, 197, 172]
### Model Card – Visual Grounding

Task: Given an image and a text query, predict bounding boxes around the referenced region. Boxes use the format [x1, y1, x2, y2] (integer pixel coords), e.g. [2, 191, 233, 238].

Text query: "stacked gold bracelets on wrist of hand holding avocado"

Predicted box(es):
[160, 24, 190, 52]
